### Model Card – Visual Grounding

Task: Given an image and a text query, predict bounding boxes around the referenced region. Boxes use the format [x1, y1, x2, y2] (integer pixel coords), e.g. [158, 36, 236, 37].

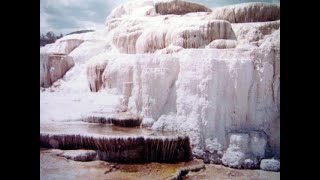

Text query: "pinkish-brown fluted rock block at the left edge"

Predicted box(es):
[40, 54, 74, 88]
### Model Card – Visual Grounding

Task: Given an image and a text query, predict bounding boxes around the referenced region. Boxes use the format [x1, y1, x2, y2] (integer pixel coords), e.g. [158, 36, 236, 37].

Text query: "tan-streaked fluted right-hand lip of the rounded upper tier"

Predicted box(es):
[136, 21, 234, 53]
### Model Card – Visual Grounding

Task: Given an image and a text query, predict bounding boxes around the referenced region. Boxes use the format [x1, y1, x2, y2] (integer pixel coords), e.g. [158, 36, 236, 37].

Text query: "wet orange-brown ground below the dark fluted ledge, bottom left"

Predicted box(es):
[40, 149, 204, 180]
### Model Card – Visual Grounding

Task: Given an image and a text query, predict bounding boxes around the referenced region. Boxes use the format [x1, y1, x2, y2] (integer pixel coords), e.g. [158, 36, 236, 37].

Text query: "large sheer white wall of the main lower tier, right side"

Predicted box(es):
[82, 36, 280, 168]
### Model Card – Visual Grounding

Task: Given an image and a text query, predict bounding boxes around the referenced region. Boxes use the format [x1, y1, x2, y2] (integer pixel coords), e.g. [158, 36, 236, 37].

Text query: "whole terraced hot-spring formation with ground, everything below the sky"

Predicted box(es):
[40, 0, 280, 180]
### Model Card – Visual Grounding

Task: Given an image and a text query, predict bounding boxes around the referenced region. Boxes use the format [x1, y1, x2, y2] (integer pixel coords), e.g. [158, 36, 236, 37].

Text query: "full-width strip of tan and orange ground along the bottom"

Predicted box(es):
[40, 148, 280, 180]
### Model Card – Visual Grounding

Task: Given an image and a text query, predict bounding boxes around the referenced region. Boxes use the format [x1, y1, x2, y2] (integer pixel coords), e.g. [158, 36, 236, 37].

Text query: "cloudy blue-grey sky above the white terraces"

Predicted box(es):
[40, 0, 280, 35]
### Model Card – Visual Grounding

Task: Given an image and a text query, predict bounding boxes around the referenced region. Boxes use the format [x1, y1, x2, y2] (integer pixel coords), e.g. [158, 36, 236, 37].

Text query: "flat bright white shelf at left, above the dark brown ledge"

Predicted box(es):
[40, 92, 119, 123]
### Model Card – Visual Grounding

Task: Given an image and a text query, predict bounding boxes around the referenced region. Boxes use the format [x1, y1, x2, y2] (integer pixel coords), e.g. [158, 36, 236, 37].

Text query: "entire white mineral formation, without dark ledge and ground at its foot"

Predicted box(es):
[40, 1, 280, 167]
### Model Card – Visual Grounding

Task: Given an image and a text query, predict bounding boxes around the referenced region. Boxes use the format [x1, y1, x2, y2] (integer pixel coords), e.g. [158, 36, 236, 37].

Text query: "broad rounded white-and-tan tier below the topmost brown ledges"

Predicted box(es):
[109, 15, 235, 54]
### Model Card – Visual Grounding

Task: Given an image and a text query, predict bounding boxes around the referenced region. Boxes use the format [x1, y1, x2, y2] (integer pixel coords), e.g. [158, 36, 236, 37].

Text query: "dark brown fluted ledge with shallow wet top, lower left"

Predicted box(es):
[40, 123, 191, 163]
